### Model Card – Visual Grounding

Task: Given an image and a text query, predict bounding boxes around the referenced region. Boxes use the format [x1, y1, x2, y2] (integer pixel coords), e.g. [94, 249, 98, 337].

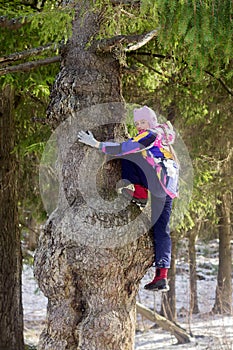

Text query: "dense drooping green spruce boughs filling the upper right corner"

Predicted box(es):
[157, 0, 233, 76]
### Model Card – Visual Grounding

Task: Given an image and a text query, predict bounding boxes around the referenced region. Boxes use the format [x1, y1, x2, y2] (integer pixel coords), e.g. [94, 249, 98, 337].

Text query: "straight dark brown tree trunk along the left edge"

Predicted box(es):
[0, 86, 24, 350]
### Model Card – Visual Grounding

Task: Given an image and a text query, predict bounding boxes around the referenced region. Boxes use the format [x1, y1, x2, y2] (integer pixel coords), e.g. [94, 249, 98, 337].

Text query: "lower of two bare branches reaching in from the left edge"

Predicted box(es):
[0, 56, 61, 76]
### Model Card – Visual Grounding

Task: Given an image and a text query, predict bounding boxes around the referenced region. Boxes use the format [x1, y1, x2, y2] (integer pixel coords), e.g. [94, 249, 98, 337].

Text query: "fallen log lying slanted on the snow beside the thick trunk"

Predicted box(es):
[136, 303, 191, 344]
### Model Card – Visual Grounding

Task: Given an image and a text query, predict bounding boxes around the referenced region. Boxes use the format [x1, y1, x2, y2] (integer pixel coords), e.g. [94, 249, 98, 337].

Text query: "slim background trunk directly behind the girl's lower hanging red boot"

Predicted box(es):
[161, 232, 177, 322]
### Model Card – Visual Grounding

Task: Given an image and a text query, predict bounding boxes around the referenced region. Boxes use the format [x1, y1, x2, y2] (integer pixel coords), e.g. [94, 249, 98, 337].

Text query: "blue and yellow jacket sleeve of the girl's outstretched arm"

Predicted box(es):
[100, 131, 156, 156]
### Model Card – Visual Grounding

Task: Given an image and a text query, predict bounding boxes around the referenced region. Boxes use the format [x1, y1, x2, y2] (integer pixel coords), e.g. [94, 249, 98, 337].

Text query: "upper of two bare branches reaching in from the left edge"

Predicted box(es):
[0, 44, 57, 65]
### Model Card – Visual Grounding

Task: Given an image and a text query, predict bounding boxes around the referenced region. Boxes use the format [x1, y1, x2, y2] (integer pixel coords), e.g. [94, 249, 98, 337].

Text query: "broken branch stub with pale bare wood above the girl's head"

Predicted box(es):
[92, 29, 158, 53]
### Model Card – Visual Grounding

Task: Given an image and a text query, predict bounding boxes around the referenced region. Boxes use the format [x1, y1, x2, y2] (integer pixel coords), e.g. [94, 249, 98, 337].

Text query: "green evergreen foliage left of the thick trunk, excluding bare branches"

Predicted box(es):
[0, 0, 73, 235]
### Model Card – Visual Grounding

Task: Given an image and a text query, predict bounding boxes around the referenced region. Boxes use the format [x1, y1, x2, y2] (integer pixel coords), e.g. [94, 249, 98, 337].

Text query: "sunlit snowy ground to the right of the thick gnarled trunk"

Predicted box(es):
[135, 272, 233, 350]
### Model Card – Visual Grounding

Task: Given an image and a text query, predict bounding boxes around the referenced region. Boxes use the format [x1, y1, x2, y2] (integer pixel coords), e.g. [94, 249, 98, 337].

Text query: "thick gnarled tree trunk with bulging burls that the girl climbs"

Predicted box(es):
[35, 1, 153, 350]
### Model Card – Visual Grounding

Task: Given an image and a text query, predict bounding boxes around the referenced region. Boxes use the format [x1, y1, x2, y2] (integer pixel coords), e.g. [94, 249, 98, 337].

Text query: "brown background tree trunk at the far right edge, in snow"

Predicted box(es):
[213, 191, 232, 314]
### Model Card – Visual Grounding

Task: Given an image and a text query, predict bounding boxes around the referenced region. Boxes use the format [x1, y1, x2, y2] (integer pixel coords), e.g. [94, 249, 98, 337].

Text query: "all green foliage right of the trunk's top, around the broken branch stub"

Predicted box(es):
[93, 0, 233, 79]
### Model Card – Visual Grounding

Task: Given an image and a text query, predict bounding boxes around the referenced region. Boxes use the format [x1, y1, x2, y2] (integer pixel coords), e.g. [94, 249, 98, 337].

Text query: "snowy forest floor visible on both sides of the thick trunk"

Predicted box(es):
[23, 240, 233, 350]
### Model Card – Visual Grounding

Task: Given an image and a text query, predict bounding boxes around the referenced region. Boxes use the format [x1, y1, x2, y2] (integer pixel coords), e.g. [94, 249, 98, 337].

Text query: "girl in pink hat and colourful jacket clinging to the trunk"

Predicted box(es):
[78, 106, 179, 291]
